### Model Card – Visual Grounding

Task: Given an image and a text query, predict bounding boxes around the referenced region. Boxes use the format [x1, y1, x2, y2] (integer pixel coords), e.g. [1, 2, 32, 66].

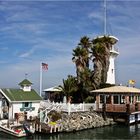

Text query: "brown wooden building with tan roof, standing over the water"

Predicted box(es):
[91, 86, 140, 123]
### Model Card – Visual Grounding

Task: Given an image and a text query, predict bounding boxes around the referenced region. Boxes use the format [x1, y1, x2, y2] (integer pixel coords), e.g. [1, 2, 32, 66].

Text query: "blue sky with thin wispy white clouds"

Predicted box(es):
[0, 0, 140, 91]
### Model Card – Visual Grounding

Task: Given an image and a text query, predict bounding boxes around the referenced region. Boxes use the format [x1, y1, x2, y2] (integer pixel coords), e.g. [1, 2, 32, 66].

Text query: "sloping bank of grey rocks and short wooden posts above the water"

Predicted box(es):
[40, 111, 116, 133]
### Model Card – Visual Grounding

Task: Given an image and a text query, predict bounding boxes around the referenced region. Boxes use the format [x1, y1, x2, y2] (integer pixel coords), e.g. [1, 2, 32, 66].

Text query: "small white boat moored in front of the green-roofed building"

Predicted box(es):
[0, 121, 35, 137]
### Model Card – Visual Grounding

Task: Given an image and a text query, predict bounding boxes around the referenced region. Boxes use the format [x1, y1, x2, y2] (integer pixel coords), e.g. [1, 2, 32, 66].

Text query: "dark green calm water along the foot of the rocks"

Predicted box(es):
[0, 124, 140, 140]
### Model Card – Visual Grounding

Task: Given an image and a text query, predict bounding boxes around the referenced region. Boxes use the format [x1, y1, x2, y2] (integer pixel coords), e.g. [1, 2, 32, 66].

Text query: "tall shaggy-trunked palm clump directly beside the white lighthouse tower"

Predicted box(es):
[91, 36, 113, 86]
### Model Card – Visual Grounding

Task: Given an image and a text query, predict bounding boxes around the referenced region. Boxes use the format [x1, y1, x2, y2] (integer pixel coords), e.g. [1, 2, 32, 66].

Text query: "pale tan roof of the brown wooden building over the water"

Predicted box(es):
[91, 86, 140, 93]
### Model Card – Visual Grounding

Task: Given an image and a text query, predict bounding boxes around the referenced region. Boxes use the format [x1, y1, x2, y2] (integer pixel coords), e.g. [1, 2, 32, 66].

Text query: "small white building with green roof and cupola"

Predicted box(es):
[0, 79, 42, 120]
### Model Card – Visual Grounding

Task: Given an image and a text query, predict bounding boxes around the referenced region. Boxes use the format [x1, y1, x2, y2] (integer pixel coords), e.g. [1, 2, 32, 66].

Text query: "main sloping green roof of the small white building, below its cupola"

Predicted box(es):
[2, 89, 42, 101]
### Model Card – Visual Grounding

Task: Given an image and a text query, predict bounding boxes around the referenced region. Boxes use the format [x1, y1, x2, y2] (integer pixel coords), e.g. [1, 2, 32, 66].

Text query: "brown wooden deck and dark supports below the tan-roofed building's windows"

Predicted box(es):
[97, 104, 140, 125]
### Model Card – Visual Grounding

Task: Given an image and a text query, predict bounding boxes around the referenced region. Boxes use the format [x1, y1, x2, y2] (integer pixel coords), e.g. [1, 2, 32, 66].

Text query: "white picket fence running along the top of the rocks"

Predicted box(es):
[40, 101, 96, 114]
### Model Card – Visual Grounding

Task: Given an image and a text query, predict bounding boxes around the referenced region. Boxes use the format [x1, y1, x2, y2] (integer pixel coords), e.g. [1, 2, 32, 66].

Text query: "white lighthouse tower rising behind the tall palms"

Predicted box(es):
[106, 36, 119, 84]
